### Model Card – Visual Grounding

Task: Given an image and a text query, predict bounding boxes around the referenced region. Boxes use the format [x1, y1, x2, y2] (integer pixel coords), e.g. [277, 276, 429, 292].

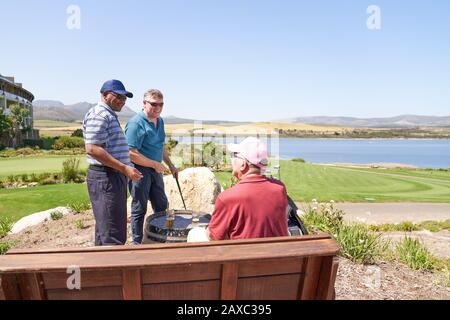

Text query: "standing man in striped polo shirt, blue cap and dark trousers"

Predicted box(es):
[82, 80, 142, 246]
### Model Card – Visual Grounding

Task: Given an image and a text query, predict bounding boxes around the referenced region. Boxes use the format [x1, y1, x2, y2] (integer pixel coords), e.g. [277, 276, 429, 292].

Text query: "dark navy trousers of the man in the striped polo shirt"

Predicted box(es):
[87, 170, 127, 246]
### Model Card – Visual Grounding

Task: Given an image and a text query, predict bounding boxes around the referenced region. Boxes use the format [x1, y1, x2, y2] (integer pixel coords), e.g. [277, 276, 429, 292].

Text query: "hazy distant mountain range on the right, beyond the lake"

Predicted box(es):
[279, 115, 450, 128]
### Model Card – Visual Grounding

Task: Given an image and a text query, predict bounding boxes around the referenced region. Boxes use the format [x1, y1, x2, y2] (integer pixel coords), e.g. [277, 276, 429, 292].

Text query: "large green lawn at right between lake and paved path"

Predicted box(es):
[216, 161, 450, 203]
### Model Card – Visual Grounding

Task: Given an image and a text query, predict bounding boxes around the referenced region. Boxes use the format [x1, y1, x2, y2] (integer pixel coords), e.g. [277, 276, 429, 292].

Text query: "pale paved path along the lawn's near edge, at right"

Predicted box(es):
[297, 202, 450, 224]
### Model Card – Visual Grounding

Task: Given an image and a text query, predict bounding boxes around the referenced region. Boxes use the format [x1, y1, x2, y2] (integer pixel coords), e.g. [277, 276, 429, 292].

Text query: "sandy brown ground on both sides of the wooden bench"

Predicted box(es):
[2, 212, 450, 300]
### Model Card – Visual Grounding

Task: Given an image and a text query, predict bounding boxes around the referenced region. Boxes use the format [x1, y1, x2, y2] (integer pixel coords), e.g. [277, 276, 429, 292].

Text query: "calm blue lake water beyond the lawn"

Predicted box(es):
[176, 137, 450, 168]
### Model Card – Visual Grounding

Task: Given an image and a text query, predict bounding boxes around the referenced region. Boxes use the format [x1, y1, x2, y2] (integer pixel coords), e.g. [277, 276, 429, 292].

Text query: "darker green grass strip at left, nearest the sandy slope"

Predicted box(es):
[0, 184, 89, 221]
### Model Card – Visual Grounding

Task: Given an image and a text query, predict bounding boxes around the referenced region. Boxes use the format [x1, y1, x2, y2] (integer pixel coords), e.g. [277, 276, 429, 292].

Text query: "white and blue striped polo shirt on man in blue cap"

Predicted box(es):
[82, 102, 131, 165]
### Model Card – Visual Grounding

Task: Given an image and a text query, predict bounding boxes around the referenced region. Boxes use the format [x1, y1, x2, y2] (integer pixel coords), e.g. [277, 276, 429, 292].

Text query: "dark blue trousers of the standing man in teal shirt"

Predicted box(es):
[129, 164, 168, 244]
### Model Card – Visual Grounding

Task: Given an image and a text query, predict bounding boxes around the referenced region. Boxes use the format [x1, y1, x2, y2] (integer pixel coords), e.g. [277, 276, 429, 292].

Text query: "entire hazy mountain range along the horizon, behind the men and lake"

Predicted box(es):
[33, 100, 450, 128]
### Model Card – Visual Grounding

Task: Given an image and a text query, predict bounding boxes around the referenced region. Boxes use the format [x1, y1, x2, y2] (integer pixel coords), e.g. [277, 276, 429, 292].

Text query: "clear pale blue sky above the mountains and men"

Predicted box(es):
[0, 0, 450, 121]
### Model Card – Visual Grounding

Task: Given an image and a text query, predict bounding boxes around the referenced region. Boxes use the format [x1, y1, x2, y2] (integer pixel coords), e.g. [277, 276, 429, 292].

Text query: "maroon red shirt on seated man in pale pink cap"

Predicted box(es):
[208, 175, 288, 240]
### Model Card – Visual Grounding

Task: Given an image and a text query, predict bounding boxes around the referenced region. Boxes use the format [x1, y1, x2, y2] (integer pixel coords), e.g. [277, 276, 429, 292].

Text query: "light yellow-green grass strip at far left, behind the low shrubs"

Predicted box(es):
[0, 156, 87, 180]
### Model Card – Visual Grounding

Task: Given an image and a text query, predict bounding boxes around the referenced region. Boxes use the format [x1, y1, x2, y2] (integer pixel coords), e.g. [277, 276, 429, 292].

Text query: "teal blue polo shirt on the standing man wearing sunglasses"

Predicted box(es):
[125, 111, 166, 162]
